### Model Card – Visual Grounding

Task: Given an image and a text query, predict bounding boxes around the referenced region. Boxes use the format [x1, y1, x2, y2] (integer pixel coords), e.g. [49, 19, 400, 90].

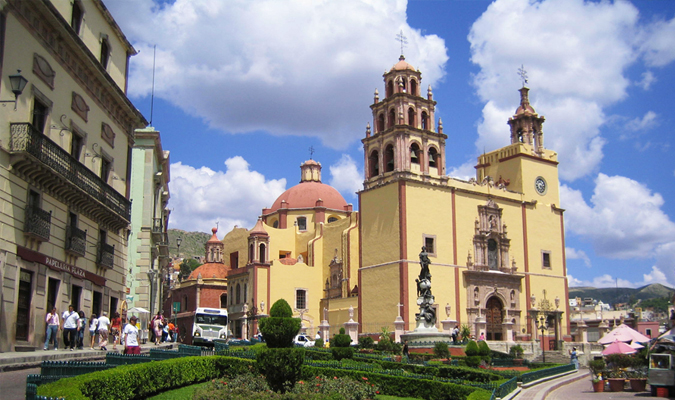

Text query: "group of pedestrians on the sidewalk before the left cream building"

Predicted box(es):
[43, 305, 140, 354]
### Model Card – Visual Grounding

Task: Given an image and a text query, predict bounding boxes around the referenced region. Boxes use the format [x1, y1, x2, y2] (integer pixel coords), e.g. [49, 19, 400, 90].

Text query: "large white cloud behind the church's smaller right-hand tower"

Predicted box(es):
[468, 0, 675, 181]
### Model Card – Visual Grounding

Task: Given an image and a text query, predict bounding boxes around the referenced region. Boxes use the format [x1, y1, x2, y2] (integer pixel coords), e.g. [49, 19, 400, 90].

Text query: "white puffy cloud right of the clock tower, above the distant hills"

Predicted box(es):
[560, 174, 675, 259]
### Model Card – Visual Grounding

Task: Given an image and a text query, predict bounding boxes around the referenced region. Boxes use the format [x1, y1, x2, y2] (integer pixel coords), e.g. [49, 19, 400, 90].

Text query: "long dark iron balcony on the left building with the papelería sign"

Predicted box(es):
[9, 123, 131, 229]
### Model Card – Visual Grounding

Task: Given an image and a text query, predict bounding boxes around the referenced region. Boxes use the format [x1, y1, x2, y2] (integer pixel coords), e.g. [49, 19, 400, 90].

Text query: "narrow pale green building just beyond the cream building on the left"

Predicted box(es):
[126, 127, 173, 315]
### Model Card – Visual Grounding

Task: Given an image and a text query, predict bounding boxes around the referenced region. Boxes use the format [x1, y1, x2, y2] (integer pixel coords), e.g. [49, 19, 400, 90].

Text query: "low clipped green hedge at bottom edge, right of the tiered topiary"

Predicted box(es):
[301, 365, 490, 400]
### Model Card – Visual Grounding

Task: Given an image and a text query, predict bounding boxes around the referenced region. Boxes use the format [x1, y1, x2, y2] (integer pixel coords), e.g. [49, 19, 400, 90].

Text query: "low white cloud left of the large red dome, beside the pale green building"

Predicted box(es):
[169, 156, 286, 232]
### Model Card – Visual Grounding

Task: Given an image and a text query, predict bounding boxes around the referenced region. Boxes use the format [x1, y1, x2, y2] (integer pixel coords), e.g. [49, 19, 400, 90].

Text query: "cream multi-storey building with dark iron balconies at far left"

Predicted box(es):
[0, 0, 147, 351]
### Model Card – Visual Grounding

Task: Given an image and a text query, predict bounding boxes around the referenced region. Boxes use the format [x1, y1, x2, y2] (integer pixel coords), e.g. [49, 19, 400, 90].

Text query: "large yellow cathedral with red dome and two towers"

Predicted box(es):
[215, 56, 570, 348]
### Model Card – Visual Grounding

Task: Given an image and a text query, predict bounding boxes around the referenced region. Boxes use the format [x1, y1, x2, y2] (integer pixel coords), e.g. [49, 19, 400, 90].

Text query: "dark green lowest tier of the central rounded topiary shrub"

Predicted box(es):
[257, 347, 305, 393]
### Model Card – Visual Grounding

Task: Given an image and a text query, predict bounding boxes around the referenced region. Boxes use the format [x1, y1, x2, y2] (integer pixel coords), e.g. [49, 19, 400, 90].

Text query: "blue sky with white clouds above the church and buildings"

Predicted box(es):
[106, 0, 675, 287]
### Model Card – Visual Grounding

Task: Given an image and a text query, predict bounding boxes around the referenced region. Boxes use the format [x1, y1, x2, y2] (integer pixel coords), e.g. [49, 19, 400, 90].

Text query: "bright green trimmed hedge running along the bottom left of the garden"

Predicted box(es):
[38, 356, 254, 400]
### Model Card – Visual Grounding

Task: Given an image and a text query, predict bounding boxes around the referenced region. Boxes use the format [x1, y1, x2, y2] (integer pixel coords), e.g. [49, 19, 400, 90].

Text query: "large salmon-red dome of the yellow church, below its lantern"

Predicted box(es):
[270, 181, 347, 212]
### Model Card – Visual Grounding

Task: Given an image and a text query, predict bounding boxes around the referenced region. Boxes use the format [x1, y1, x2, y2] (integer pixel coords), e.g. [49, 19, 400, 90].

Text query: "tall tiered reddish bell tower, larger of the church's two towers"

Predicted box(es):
[362, 56, 447, 189]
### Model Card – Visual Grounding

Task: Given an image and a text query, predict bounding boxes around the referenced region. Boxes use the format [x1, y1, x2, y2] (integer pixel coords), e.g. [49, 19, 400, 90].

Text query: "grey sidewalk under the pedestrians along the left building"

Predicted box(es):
[0, 342, 178, 372]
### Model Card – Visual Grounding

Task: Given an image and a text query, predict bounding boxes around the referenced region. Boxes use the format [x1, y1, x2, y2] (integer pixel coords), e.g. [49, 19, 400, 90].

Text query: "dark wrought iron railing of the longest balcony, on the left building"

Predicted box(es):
[10, 122, 131, 220]
